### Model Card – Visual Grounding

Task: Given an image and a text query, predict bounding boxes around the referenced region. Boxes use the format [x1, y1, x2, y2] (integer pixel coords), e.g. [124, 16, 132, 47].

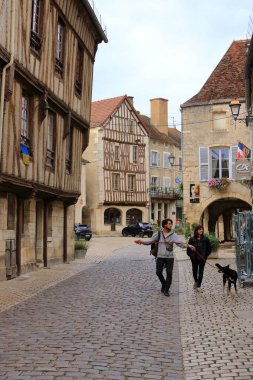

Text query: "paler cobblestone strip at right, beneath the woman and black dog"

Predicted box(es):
[179, 253, 253, 380]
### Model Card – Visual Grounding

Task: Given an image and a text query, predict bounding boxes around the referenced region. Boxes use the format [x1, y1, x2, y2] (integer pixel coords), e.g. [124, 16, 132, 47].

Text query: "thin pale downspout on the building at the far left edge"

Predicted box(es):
[0, 0, 15, 159]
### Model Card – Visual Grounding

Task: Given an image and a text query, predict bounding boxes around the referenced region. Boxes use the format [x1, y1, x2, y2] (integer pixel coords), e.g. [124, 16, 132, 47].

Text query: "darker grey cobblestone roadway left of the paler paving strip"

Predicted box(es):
[0, 238, 184, 380]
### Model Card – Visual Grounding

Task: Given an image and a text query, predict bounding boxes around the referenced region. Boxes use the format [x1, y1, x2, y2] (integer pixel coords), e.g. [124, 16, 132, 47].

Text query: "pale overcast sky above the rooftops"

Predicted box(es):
[93, 0, 253, 129]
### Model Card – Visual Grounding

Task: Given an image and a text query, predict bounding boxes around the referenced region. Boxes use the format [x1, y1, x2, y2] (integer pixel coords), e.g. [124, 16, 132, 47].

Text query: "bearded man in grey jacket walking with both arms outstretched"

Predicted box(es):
[135, 219, 195, 297]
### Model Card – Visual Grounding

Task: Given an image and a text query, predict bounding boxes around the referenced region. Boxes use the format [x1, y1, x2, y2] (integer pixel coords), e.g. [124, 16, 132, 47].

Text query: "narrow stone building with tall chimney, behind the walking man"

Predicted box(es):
[141, 98, 182, 226]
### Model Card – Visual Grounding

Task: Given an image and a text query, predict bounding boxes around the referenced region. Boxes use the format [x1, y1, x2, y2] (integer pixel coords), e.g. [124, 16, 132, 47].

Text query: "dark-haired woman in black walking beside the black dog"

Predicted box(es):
[187, 225, 212, 292]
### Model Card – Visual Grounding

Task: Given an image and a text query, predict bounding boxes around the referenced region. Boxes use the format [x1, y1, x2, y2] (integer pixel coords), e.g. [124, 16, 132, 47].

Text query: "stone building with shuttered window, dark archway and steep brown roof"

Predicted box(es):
[181, 40, 252, 241]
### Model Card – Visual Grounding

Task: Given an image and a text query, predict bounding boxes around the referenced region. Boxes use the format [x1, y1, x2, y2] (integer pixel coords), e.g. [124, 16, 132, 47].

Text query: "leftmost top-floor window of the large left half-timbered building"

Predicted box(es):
[30, 0, 43, 53]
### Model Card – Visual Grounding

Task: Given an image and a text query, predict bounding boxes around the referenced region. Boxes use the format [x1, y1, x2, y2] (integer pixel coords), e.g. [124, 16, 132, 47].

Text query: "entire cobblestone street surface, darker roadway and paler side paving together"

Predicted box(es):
[0, 237, 253, 380]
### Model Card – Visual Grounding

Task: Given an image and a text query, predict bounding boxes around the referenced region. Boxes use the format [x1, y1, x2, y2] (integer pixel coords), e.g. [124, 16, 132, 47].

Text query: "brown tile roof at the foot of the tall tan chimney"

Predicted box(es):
[139, 115, 181, 147]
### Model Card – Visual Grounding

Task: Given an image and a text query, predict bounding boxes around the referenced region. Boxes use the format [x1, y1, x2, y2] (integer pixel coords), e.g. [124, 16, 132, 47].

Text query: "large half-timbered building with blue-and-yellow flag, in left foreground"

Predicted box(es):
[0, 0, 107, 279]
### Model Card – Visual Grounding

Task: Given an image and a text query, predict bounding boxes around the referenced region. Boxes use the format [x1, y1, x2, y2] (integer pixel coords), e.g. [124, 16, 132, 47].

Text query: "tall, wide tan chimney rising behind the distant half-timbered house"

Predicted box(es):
[150, 98, 169, 135]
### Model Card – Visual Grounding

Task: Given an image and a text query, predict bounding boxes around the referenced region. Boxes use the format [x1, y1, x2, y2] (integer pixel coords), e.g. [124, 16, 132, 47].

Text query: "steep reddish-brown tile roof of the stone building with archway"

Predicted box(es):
[181, 39, 250, 108]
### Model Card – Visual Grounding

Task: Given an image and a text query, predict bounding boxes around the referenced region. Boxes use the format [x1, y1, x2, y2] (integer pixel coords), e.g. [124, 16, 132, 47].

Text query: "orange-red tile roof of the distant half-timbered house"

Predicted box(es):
[90, 95, 127, 127]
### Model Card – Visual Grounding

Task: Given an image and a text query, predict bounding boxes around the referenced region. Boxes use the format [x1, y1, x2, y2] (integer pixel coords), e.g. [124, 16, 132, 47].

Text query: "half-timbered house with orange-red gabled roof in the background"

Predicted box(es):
[82, 95, 149, 234]
